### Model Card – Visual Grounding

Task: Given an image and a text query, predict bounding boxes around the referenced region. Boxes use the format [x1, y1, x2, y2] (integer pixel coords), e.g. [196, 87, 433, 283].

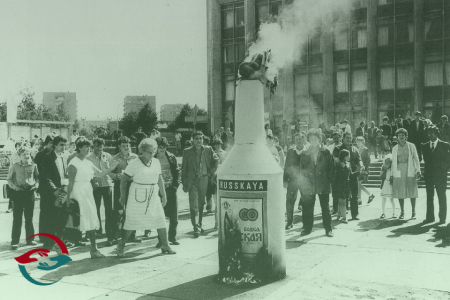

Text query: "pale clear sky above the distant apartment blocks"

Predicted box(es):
[0, 0, 207, 120]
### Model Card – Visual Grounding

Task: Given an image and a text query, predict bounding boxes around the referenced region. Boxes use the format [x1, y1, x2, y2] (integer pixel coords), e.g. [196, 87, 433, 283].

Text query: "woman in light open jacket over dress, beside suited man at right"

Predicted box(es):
[392, 128, 421, 219]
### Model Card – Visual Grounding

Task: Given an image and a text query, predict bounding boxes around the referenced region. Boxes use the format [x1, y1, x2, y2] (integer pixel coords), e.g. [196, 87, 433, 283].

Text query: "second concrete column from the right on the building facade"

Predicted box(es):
[367, 1, 378, 123]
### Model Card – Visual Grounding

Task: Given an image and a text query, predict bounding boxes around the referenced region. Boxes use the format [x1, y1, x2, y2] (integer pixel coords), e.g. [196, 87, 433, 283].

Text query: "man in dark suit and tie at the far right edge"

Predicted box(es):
[422, 126, 450, 224]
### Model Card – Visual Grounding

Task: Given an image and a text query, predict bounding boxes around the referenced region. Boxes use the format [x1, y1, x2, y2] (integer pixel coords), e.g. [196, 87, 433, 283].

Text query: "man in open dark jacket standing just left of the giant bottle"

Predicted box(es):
[181, 131, 219, 237]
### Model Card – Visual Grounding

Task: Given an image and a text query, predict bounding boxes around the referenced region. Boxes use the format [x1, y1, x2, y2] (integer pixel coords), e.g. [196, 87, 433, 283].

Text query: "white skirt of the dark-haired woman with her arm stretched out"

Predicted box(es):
[70, 181, 100, 231]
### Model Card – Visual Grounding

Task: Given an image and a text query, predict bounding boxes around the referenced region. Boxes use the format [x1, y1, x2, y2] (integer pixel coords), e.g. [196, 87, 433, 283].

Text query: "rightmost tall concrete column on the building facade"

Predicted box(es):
[414, 0, 425, 111]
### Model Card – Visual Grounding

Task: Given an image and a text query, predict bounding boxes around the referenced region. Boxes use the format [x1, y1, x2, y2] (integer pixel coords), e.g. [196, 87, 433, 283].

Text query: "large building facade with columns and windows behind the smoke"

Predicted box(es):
[207, 0, 450, 130]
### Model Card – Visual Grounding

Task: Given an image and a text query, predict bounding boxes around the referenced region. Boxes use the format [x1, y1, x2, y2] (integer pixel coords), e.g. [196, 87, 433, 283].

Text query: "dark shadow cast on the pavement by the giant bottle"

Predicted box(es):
[136, 275, 260, 300]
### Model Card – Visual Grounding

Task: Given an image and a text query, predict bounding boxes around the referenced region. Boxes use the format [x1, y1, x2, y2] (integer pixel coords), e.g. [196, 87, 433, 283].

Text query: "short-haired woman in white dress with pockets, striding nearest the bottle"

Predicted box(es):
[117, 138, 176, 257]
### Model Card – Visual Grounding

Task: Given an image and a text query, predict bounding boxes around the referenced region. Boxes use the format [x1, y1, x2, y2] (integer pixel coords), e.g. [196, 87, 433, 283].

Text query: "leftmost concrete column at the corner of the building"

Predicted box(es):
[206, 0, 223, 132]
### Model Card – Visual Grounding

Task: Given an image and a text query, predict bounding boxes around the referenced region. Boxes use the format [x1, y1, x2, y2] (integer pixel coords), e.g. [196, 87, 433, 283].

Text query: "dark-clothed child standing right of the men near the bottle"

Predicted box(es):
[332, 149, 351, 224]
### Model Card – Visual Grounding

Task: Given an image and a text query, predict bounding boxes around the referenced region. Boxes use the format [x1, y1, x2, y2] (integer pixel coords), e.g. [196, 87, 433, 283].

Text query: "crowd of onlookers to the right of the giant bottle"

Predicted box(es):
[282, 112, 450, 240]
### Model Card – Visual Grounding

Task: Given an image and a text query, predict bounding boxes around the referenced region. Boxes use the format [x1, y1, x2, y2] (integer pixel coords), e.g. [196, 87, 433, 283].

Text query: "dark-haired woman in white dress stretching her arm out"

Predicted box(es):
[66, 137, 117, 258]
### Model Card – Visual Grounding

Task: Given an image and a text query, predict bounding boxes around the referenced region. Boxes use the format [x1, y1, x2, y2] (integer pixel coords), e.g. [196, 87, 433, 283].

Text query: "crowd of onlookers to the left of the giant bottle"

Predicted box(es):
[7, 125, 232, 258]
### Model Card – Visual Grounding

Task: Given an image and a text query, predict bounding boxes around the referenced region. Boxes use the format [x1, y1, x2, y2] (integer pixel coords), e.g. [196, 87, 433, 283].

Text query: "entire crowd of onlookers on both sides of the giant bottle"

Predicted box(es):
[7, 112, 450, 258]
